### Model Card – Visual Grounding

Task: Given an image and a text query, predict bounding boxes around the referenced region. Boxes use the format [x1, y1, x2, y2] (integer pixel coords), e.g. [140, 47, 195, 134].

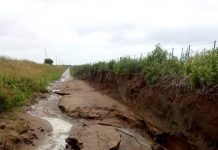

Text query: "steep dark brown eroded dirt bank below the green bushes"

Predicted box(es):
[80, 72, 218, 150]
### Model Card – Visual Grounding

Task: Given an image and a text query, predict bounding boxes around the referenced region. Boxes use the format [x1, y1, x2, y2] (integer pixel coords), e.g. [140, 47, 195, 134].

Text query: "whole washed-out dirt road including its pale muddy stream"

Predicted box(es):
[25, 70, 157, 150]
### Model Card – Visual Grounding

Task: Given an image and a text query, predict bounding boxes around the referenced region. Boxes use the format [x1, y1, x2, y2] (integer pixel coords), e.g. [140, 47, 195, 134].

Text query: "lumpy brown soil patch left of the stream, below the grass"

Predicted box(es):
[0, 112, 51, 150]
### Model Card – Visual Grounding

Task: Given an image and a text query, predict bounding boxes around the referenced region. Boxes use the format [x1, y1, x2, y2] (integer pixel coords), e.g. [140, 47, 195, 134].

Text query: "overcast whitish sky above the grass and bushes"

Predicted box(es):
[0, 0, 218, 65]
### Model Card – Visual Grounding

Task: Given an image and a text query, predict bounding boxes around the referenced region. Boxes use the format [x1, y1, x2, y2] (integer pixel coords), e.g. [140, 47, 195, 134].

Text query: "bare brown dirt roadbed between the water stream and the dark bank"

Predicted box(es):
[58, 79, 163, 150]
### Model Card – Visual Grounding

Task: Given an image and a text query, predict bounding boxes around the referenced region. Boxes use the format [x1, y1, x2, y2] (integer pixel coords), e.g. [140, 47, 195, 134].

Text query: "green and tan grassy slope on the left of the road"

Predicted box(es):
[0, 57, 64, 112]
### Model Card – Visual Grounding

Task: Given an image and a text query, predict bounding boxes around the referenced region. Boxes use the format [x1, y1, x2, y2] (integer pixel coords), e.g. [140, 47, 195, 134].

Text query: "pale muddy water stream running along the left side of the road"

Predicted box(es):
[28, 69, 73, 150]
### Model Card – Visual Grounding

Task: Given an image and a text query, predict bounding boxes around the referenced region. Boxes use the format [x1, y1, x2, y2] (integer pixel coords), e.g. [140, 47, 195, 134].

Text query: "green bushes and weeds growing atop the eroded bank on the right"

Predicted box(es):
[71, 45, 218, 88]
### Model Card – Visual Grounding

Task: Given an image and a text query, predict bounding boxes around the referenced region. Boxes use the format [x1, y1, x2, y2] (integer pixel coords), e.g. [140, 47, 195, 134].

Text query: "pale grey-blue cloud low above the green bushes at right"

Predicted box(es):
[146, 26, 218, 45]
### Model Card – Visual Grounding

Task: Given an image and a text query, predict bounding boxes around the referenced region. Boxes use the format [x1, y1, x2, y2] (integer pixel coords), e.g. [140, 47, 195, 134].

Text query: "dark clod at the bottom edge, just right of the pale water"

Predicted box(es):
[65, 137, 83, 150]
